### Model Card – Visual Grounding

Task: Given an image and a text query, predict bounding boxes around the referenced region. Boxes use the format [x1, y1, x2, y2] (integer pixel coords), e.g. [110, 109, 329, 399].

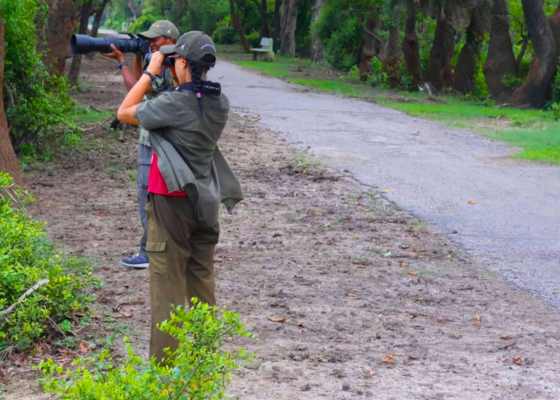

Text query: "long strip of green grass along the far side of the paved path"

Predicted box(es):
[219, 46, 560, 164]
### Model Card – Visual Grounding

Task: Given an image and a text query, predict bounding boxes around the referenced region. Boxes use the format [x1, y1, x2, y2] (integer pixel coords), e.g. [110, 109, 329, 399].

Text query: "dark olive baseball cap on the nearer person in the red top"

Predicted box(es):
[159, 31, 216, 65]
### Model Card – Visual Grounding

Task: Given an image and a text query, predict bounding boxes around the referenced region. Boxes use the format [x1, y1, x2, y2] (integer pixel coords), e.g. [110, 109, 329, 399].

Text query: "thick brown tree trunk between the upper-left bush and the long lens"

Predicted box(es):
[39, 0, 78, 75]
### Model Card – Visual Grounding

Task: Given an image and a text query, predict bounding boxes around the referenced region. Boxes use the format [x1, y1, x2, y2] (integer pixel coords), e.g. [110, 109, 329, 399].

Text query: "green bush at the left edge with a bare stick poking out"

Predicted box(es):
[0, 172, 95, 350]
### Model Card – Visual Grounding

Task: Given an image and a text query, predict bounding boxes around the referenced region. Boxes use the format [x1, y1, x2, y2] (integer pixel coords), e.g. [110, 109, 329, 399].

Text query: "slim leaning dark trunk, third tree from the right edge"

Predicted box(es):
[454, 3, 488, 94]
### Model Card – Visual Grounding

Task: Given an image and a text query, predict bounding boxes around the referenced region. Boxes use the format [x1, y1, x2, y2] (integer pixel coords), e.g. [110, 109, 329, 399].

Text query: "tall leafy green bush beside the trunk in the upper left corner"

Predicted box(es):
[0, 0, 73, 157]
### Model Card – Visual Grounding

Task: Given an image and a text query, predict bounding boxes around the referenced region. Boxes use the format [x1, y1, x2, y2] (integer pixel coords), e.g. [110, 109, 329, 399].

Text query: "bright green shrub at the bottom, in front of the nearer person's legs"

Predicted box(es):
[38, 299, 252, 400]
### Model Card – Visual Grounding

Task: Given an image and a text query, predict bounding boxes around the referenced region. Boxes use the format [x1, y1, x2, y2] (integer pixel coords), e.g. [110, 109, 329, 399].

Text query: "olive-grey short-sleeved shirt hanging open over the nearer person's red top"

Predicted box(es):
[136, 85, 243, 227]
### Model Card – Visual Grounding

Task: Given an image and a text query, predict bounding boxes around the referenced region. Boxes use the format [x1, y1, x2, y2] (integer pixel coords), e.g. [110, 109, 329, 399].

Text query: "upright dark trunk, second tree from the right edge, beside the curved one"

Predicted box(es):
[484, 0, 517, 99]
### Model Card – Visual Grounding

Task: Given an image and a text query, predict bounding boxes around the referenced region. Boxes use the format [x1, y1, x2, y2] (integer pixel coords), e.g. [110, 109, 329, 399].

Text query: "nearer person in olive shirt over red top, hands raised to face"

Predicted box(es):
[118, 31, 242, 361]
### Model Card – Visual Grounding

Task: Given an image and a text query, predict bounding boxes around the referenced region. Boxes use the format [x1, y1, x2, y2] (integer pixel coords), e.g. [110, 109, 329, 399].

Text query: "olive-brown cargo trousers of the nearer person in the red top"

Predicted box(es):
[146, 194, 220, 361]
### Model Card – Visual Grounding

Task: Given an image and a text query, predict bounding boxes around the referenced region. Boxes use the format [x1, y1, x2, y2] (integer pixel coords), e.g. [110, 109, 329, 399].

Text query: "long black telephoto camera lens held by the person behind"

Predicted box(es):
[70, 33, 150, 56]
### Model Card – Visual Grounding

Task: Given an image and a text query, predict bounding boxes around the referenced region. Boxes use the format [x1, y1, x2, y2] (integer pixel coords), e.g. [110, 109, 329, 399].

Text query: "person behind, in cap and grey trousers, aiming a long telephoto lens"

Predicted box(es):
[103, 20, 179, 268]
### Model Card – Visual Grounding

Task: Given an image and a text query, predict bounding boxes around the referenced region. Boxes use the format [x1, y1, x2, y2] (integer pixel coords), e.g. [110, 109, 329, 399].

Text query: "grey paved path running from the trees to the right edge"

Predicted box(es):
[215, 62, 560, 307]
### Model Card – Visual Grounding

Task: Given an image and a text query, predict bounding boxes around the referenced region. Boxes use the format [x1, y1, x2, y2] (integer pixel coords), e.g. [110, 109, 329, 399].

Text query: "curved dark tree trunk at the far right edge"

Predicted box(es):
[512, 0, 558, 108]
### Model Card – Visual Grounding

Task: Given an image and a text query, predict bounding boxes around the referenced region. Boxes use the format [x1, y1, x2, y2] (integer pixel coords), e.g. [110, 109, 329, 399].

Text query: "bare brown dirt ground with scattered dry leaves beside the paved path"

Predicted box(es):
[3, 60, 560, 399]
